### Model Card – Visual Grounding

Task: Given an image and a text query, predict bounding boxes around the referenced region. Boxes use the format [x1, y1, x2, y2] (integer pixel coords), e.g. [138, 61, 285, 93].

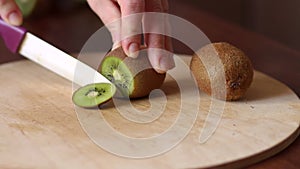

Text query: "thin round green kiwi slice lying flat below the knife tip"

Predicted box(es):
[72, 83, 116, 108]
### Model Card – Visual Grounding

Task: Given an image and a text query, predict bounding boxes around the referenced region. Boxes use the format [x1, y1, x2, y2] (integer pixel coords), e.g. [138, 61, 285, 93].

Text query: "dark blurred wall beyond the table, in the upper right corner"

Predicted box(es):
[186, 0, 300, 50]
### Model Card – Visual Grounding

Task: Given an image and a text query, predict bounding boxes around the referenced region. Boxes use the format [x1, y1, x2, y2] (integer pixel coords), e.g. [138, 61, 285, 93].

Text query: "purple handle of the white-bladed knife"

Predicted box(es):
[0, 18, 27, 53]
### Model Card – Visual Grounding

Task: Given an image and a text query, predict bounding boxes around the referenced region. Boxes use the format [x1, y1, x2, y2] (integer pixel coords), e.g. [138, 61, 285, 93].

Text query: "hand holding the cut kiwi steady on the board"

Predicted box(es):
[87, 0, 175, 73]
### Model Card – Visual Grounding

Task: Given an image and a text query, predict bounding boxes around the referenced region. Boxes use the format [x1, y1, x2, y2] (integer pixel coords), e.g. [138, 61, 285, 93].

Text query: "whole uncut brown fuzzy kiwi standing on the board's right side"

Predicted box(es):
[190, 42, 254, 101]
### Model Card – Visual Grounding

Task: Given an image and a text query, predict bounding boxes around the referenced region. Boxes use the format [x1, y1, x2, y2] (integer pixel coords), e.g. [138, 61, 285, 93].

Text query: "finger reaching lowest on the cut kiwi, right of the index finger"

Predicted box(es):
[144, 0, 174, 73]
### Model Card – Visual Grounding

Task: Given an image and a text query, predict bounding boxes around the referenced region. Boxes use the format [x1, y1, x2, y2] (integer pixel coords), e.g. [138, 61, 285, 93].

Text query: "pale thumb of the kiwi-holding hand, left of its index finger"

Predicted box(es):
[87, 0, 121, 48]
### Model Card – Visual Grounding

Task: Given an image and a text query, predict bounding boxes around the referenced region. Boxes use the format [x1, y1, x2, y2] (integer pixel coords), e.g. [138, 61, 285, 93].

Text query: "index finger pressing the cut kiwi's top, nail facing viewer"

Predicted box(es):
[118, 0, 145, 58]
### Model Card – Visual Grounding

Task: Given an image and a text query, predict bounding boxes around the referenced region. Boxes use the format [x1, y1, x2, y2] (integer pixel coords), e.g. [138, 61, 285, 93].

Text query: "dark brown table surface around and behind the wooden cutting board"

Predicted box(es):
[0, 1, 300, 169]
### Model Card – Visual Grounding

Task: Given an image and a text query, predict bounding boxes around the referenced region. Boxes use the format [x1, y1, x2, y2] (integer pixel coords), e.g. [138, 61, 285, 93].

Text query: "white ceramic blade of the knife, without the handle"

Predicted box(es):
[19, 33, 110, 86]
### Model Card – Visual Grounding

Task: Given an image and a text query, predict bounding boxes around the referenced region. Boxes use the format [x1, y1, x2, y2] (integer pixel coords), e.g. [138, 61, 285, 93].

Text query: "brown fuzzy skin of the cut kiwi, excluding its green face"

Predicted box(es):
[98, 47, 166, 99]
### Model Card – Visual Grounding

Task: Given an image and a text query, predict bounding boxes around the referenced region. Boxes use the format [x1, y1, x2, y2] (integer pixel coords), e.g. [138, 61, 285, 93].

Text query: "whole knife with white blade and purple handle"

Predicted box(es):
[0, 18, 111, 86]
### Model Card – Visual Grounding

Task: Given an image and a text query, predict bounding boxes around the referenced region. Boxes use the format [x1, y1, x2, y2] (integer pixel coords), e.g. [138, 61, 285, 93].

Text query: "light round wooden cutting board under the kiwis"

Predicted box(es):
[0, 54, 300, 169]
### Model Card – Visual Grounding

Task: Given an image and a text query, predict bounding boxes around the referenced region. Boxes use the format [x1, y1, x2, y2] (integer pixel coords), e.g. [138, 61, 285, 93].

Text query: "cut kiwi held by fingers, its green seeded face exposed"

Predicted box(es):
[99, 47, 166, 98]
